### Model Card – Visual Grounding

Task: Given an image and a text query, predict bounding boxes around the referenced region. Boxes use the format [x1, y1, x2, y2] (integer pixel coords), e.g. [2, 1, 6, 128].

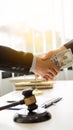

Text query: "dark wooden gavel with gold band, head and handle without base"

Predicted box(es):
[0, 88, 38, 112]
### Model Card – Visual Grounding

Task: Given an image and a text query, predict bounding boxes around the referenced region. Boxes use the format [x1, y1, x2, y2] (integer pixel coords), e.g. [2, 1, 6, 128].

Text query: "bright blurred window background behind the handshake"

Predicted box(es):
[0, 0, 73, 93]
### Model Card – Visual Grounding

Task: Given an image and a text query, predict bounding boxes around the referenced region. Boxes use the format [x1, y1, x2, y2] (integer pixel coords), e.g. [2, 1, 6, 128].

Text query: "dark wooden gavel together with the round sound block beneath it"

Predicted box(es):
[0, 88, 51, 123]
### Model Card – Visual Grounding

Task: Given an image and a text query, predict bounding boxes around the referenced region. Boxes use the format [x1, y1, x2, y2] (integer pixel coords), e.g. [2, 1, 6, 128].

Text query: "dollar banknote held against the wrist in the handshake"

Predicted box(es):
[51, 49, 73, 69]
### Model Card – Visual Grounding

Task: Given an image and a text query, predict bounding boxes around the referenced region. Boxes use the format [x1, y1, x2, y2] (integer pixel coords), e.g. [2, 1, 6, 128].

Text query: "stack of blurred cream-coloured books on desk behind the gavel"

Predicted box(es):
[11, 79, 54, 90]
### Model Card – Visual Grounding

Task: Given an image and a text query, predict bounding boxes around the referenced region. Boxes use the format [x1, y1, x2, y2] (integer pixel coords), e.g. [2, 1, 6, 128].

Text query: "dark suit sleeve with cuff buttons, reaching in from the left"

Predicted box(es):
[0, 46, 33, 74]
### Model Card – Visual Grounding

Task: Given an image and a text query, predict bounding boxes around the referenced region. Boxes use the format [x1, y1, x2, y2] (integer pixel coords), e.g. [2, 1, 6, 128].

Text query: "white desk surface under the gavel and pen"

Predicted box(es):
[0, 81, 73, 130]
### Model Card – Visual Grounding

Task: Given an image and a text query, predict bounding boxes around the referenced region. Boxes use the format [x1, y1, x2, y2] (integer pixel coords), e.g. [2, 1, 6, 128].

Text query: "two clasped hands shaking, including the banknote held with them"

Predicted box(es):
[34, 46, 73, 81]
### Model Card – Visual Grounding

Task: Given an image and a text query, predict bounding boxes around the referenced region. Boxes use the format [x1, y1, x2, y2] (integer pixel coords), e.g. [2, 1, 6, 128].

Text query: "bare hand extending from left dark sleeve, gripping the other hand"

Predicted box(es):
[34, 52, 60, 80]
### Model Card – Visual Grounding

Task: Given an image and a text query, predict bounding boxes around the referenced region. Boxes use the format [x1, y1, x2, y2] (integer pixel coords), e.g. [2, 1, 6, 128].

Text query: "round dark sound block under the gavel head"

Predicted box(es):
[14, 107, 51, 123]
